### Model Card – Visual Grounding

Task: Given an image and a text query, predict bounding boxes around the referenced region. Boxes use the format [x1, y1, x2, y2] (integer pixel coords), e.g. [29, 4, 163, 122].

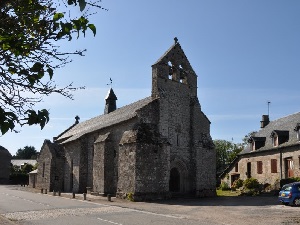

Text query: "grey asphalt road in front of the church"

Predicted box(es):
[0, 186, 300, 225]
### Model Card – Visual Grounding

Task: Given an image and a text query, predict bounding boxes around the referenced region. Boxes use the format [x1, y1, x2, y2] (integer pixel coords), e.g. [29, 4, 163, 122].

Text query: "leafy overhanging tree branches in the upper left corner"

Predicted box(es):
[0, 0, 103, 134]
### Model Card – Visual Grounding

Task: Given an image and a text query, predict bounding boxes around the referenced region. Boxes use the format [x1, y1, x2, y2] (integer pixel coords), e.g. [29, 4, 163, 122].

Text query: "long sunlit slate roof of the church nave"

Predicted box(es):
[57, 97, 155, 143]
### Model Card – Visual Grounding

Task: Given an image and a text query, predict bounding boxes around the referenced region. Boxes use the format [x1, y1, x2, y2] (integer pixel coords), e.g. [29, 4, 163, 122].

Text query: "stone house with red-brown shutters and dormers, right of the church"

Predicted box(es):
[221, 112, 300, 188]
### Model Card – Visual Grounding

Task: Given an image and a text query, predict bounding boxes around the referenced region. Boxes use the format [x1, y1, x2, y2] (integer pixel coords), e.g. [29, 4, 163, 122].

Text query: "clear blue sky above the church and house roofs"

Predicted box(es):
[0, 0, 300, 155]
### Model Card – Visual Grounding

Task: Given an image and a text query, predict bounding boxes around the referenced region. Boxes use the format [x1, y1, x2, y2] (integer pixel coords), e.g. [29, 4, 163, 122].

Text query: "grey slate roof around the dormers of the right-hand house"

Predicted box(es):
[240, 112, 300, 155]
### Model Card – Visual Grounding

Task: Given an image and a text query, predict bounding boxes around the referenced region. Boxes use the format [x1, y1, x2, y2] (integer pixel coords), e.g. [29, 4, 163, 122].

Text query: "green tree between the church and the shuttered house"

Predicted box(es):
[213, 140, 243, 174]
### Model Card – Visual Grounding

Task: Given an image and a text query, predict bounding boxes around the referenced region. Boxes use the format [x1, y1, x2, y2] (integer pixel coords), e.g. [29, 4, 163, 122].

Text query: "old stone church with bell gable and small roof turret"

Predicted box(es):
[36, 38, 216, 201]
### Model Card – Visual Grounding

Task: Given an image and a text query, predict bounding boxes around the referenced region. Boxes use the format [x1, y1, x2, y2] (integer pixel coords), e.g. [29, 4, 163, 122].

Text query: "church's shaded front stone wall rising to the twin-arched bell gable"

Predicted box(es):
[152, 42, 216, 196]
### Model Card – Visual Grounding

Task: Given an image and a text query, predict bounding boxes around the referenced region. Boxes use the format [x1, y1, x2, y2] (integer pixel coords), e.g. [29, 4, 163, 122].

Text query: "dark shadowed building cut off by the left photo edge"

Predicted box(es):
[0, 145, 11, 184]
